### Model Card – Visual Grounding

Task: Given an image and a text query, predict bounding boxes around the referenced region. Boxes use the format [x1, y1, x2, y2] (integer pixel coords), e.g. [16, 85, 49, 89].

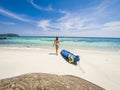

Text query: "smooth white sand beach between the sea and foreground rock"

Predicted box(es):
[0, 47, 120, 90]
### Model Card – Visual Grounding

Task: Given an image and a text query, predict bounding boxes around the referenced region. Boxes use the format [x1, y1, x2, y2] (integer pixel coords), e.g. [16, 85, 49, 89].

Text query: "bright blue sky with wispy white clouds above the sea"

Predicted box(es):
[0, 0, 120, 37]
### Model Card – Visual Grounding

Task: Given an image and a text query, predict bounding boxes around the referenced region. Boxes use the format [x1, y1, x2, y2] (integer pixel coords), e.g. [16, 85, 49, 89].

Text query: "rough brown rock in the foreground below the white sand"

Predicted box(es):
[0, 73, 105, 90]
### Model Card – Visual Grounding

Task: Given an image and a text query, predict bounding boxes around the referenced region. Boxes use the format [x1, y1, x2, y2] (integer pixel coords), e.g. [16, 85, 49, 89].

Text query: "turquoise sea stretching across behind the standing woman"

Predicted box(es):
[0, 36, 120, 51]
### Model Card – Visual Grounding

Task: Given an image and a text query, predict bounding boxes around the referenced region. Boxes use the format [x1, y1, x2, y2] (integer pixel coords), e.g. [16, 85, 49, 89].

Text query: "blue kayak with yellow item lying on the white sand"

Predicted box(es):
[61, 50, 80, 65]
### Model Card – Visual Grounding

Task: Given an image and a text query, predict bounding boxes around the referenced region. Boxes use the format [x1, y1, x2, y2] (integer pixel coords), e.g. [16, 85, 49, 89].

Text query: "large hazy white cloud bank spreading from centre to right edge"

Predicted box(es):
[34, 1, 120, 37]
